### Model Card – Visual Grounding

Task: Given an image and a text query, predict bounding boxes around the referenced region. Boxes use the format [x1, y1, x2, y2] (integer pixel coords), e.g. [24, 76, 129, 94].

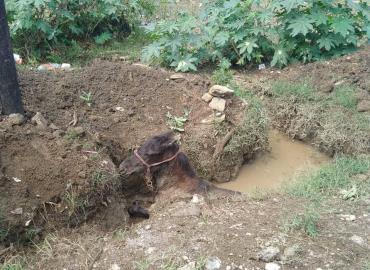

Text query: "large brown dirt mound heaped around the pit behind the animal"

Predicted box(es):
[0, 60, 266, 246]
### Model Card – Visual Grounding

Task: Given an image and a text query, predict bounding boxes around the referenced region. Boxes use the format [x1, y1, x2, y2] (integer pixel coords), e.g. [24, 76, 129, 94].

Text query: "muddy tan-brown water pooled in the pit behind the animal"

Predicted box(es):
[218, 130, 329, 193]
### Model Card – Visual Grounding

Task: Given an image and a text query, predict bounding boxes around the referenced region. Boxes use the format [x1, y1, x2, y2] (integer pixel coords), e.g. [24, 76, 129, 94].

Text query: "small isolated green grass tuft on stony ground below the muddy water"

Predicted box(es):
[286, 206, 320, 237]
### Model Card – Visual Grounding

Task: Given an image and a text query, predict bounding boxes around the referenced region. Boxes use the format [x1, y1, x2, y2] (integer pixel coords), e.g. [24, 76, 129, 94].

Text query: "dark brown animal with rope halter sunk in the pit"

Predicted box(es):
[119, 132, 240, 217]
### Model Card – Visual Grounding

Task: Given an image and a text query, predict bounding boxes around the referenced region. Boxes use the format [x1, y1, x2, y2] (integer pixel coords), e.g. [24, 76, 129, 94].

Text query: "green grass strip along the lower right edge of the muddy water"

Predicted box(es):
[287, 156, 370, 198]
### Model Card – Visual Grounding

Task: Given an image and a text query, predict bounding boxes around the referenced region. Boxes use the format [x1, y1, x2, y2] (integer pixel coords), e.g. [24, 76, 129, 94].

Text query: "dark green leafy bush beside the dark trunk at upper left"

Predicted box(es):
[6, 0, 154, 58]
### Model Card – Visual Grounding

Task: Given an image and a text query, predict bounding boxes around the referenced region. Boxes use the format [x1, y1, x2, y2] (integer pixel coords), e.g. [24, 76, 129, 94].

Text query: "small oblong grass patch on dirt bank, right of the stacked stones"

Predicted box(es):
[271, 81, 315, 100]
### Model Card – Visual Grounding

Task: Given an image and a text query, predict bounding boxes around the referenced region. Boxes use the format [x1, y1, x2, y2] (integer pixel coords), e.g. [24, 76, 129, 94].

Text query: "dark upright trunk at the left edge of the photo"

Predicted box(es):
[0, 0, 24, 114]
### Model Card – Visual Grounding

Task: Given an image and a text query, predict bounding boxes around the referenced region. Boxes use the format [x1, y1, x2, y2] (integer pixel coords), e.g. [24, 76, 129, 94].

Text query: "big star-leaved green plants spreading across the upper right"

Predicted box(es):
[142, 0, 370, 71]
